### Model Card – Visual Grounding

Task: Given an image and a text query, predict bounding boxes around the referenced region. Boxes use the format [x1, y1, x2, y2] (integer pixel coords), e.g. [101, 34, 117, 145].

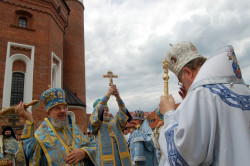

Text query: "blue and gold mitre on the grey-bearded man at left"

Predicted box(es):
[41, 88, 67, 111]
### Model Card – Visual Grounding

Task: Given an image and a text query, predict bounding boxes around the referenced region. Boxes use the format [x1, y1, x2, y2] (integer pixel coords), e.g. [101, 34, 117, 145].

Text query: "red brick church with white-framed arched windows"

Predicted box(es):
[0, 0, 88, 132]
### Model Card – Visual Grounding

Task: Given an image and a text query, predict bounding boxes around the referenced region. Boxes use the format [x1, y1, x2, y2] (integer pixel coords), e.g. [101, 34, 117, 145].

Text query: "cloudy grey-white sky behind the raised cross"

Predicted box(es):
[84, 0, 250, 115]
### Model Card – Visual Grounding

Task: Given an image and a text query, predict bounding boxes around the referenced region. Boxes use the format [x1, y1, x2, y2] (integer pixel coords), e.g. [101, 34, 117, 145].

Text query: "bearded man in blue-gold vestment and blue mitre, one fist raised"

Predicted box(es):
[15, 88, 96, 166]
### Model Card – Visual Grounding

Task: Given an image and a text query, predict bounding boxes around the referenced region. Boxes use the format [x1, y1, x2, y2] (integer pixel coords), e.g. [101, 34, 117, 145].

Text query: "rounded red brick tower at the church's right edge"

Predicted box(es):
[63, 0, 88, 128]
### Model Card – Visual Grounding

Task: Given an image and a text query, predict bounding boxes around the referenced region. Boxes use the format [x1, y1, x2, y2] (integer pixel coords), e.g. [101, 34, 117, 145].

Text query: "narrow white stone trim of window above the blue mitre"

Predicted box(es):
[51, 52, 62, 88]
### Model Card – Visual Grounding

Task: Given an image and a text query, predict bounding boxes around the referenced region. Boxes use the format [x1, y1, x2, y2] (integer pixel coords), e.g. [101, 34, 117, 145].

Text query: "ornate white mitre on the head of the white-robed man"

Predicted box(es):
[166, 41, 202, 77]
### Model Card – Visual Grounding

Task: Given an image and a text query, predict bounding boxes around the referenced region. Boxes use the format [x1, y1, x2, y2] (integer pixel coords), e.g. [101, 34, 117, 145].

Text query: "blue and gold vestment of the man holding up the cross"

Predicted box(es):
[90, 96, 132, 166]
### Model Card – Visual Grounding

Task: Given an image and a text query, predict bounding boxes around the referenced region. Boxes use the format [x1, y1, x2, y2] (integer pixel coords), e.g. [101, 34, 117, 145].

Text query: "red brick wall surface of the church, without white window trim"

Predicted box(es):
[0, 0, 86, 131]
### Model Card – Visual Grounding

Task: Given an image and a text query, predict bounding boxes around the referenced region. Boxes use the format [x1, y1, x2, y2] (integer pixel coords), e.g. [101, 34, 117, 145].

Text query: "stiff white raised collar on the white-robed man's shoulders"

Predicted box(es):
[190, 45, 244, 89]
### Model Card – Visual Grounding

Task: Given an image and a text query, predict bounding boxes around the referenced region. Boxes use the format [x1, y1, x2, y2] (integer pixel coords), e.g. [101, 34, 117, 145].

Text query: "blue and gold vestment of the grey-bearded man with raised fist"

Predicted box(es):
[17, 117, 96, 166]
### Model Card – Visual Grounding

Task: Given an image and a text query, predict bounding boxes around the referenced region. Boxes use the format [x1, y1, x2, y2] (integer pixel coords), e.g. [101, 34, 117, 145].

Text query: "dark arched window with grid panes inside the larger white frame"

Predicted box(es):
[10, 72, 24, 105]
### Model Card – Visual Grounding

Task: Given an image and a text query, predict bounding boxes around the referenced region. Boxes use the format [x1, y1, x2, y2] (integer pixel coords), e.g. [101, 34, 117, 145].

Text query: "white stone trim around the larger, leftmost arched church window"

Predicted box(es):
[2, 42, 35, 107]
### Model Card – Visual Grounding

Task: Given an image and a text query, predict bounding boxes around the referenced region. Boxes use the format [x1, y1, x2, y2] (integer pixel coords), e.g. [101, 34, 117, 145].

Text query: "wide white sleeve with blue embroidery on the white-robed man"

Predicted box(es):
[161, 87, 216, 165]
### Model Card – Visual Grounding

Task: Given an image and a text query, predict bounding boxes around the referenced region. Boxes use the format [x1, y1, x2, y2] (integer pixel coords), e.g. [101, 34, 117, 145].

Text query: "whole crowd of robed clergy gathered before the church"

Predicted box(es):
[0, 42, 250, 166]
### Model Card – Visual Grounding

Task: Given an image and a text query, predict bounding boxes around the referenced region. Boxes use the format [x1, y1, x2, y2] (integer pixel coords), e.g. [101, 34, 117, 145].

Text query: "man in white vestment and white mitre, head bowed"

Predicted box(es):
[159, 42, 250, 166]
